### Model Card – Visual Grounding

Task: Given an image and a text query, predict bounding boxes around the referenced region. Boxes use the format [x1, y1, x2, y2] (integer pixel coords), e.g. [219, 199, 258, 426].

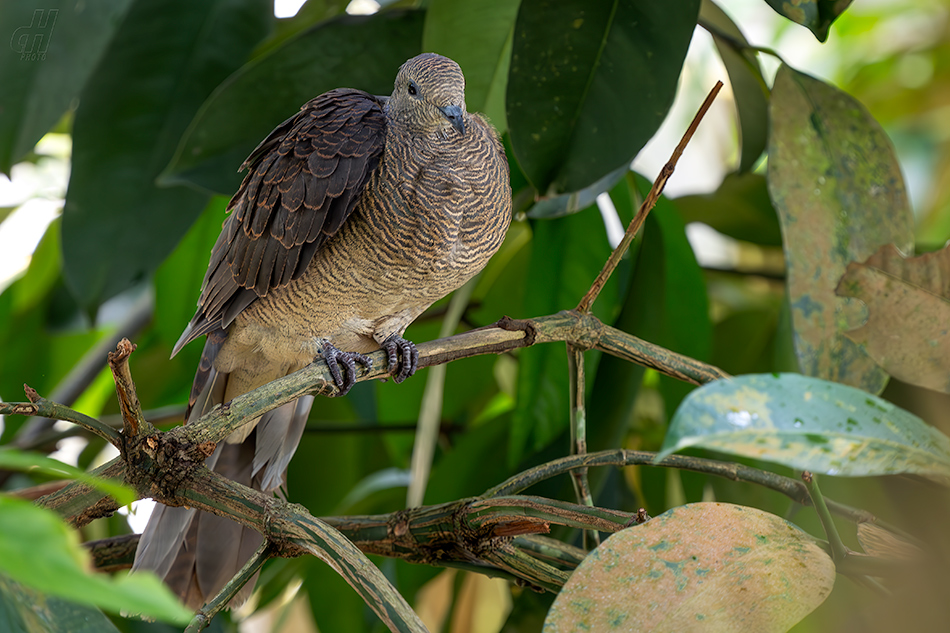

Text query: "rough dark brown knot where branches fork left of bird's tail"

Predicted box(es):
[124, 433, 215, 506]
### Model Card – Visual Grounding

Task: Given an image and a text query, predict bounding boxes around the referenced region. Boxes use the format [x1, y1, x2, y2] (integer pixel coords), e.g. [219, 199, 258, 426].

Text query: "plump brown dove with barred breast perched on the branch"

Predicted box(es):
[133, 53, 511, 609]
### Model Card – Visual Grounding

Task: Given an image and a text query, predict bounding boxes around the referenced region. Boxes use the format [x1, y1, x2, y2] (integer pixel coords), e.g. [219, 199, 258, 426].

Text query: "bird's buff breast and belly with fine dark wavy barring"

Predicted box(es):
[229, 109, 511, 365]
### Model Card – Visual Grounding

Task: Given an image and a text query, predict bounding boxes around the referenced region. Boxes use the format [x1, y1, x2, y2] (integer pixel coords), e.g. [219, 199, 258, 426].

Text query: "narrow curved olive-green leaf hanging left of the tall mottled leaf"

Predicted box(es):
[699, 0, 769, 172]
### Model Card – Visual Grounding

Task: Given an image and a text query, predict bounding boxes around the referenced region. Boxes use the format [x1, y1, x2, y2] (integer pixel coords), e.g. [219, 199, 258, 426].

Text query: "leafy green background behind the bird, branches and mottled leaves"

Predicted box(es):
[0, 0, 950, 633]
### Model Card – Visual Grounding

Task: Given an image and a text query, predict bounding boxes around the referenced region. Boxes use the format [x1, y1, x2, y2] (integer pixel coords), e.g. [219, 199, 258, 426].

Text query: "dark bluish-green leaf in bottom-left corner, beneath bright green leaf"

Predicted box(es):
[0, 574, 119, 633]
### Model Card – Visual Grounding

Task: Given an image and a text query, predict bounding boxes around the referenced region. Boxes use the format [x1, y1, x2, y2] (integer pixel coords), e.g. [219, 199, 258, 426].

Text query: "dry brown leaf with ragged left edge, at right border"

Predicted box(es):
[836, 244, 950, 393]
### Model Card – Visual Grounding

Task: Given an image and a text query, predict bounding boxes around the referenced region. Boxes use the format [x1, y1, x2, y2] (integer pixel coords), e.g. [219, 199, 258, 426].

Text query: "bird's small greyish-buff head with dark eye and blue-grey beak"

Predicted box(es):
[386, 53, 465, 134]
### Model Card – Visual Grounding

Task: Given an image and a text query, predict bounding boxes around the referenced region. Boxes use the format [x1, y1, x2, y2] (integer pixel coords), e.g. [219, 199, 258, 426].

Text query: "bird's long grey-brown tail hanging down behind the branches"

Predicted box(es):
[132, 331, 313, 610]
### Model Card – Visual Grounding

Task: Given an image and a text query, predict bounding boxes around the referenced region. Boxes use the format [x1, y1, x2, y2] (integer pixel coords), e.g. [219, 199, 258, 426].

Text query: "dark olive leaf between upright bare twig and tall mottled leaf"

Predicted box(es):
[676, 173, 782, 246]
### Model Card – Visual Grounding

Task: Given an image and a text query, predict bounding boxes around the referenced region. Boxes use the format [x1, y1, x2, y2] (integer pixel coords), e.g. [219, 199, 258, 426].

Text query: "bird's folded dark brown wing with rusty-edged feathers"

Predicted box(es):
[172, 88, 386, 355]
